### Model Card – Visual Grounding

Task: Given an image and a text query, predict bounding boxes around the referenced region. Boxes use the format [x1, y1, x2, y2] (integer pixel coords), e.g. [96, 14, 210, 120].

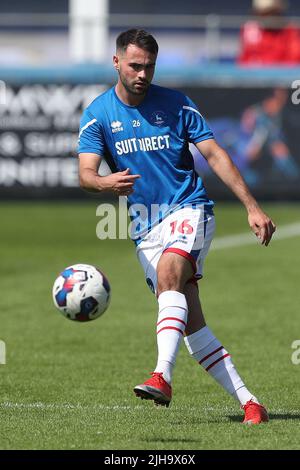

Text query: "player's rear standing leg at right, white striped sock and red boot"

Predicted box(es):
[184, 266, 268, 424]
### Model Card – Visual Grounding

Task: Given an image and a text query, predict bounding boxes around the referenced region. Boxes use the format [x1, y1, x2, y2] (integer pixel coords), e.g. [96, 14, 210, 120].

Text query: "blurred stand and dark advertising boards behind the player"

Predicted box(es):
[0, 0, 300, 199]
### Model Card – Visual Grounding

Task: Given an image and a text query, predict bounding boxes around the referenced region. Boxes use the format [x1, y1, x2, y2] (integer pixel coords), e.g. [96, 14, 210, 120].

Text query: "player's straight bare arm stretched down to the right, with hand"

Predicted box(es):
[195, 139, 276, 246]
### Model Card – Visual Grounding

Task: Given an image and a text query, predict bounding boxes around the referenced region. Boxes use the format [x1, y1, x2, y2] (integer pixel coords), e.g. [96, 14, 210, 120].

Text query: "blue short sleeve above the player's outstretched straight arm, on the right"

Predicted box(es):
[182, 97, 214, 144]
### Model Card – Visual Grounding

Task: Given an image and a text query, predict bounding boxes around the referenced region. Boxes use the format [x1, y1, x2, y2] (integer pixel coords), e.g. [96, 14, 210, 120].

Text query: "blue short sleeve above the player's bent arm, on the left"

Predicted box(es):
[78, 109, 105, 156]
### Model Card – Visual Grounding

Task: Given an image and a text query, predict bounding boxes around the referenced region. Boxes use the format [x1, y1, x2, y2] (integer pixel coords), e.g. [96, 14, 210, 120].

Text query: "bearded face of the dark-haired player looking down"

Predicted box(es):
[114, 44, 157, 95]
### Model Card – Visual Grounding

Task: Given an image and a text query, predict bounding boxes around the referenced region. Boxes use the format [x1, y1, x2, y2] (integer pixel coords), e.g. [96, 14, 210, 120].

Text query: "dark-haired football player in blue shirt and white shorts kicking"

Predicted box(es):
[79, 30, 275, 424]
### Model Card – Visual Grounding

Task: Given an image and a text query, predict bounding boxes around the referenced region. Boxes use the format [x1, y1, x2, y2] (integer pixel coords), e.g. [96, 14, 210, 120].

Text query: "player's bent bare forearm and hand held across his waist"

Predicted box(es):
[79, 153, 140, 196]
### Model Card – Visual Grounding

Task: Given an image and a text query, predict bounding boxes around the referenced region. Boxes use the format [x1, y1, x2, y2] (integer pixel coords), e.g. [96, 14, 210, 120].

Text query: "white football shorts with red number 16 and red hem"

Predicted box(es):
[136, 205, 215, 292]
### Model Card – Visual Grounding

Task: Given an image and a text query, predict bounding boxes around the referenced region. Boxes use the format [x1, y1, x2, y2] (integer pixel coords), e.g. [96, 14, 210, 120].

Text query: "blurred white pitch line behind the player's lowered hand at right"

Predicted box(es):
[211, 222, 300, 250]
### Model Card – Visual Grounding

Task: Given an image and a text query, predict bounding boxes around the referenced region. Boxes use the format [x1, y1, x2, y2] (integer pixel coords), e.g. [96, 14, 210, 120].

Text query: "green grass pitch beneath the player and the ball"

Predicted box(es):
[0, 200, 300, 450]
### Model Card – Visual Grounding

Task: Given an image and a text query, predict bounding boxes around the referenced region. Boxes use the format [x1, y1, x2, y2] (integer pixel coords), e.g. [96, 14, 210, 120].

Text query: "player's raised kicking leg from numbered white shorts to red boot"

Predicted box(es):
[135, 207, 204, 404]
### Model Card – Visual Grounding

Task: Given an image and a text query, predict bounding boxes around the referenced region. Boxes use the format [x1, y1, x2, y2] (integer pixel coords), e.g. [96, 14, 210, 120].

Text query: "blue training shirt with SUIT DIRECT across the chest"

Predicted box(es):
[78, 85, 213, 243]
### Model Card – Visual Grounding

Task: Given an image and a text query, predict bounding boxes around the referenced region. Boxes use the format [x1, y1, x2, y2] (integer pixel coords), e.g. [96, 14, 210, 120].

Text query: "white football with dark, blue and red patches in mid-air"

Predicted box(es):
[52, 264, 110, 322]
